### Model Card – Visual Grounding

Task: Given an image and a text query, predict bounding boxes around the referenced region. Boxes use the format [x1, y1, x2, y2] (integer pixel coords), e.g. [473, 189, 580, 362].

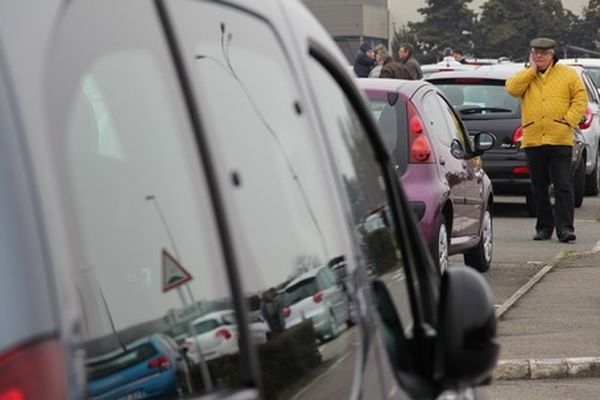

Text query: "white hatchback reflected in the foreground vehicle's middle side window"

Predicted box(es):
[283, 266, 351, 340]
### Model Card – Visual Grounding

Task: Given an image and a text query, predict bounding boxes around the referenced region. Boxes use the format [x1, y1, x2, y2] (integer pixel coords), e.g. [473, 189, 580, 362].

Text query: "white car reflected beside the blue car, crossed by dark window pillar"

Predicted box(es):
[184, 310, 269, 363]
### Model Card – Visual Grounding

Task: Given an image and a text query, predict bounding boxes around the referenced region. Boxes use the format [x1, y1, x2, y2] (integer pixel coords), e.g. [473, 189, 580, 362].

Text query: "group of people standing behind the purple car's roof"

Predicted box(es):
[354, 42, 423, 79]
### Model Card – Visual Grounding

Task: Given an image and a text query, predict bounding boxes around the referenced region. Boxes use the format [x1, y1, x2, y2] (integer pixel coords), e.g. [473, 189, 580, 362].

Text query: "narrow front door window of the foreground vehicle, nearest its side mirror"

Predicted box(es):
[311, 60, 413, 335]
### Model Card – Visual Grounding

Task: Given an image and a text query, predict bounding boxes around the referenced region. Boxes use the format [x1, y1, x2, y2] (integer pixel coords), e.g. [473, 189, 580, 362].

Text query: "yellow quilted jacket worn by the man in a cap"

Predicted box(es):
[506, 64, 588, 147]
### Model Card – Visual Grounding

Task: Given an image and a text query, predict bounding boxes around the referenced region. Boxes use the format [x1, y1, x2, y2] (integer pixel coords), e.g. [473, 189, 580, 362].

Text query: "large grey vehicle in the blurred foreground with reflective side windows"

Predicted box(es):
[0, 0, 499, 400]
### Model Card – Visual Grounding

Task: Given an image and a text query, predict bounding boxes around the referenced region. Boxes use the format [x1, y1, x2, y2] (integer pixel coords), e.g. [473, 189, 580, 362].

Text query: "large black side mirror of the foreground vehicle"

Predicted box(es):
[434, 266, 500, 389]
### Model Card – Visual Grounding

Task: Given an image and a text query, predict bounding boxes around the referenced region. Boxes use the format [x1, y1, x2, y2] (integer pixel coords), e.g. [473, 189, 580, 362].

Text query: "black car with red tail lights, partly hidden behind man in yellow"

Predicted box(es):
[428, 64, 585, 216]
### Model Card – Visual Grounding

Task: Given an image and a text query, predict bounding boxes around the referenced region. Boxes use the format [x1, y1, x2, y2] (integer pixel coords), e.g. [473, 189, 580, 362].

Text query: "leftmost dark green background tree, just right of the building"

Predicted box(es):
[408, 0, 476, 61]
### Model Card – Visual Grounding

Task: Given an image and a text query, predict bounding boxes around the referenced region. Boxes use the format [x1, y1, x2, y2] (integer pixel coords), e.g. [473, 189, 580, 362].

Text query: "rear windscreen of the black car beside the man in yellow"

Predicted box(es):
[435, 80, 520, 119]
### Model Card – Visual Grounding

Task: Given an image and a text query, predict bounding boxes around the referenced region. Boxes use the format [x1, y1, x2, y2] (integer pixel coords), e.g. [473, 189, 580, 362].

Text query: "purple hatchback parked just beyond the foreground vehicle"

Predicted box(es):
[359, 79, 495, 272]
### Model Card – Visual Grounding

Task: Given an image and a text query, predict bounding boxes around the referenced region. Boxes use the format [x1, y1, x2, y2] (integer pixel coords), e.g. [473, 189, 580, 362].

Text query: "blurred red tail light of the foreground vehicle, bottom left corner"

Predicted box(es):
[0, 341, 69, 400]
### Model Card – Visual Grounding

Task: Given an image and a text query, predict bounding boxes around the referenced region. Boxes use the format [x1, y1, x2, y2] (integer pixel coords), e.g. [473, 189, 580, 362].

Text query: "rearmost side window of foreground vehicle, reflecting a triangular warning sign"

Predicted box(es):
[47, 0, 232, 398]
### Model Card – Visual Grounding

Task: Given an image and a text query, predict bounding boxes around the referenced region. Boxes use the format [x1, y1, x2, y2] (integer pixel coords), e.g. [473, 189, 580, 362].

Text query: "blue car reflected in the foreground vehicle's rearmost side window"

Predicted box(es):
[87, 334, 187, 400]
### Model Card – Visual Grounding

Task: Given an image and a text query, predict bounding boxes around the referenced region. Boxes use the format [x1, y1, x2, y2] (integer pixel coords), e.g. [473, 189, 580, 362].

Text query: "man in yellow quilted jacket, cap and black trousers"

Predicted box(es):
[506, 38, 588, 243]
